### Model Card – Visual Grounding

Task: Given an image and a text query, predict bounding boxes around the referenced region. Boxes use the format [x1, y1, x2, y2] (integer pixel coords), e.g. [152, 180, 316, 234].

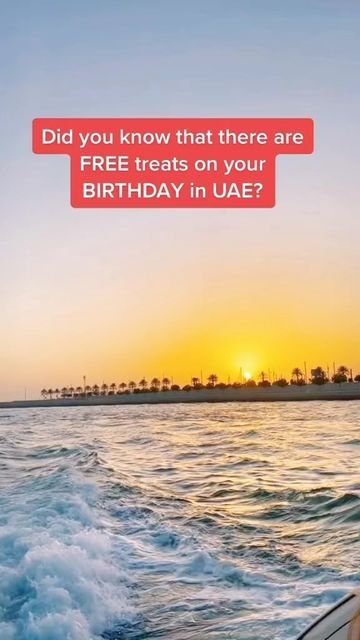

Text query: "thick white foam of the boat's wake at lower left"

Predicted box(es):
[0, 464, 134, 640]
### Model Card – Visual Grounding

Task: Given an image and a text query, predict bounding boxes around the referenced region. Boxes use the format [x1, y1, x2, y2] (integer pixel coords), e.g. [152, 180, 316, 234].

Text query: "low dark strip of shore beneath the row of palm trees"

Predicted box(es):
[0, 382, 360, 409]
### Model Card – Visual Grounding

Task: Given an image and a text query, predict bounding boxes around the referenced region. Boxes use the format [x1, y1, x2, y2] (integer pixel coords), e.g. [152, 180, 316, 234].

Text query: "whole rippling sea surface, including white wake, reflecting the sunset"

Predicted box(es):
[0, 402, 360, 640]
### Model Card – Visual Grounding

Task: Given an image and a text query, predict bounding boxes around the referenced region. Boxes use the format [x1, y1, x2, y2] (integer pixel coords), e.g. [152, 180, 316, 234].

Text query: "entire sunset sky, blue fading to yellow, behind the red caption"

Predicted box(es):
[0, 0, 360, 400]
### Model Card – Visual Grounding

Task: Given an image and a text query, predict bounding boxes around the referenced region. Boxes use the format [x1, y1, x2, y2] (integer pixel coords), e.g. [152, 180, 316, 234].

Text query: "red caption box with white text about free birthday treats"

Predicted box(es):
[33, 118, 314, 209]
